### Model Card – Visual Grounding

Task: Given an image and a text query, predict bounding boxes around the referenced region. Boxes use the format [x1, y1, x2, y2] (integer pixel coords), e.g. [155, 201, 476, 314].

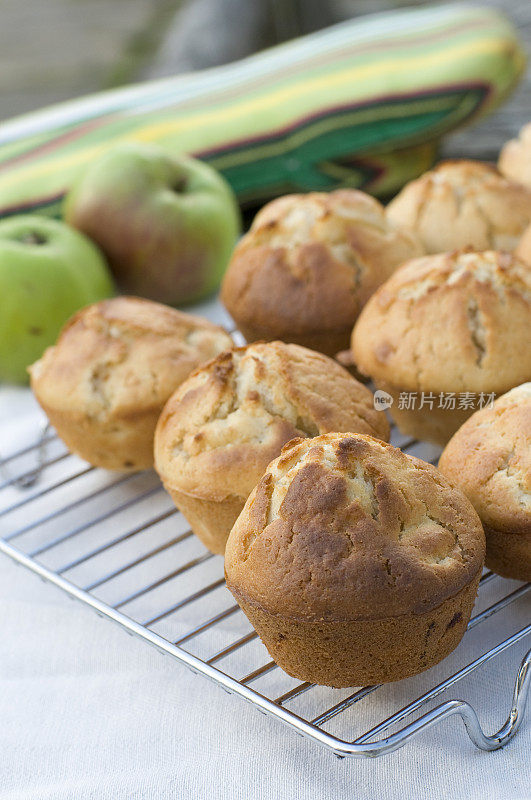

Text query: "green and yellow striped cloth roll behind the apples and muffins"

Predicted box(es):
[0, 3, 525, 216]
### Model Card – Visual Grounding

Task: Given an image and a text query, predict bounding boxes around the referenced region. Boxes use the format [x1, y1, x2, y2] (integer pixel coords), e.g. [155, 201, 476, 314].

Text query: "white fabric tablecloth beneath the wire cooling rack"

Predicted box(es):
[0, 302, 531, 800]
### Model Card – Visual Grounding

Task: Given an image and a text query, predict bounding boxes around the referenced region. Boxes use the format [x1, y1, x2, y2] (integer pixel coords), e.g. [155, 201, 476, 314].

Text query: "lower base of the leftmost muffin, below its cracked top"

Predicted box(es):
[41, 403, 161, 472]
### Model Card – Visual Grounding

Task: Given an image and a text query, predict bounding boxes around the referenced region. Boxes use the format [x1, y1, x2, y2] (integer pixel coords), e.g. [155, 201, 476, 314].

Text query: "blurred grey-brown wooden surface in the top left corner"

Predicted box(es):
[0, 0, 182, 120]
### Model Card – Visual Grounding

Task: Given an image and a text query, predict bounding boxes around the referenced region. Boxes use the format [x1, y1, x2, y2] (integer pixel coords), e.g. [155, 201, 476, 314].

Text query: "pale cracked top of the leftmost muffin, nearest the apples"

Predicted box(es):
[30, 297, 233, 417]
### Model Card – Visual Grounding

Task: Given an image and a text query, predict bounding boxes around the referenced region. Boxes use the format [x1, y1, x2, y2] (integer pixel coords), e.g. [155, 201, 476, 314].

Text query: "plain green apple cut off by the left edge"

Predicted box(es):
[0, 214, 113, 383]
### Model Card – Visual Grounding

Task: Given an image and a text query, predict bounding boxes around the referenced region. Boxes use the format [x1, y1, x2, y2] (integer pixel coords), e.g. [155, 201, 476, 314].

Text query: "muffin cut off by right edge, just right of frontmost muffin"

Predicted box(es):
[439, 383, 531, 581]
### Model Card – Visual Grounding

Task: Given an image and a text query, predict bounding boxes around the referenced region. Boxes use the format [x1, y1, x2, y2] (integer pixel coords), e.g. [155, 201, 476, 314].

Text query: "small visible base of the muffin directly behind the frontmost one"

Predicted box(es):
[165, 486, 245, 555]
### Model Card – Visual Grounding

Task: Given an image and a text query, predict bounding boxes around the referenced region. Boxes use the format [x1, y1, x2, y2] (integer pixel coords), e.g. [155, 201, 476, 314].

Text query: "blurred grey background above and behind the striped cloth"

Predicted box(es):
[0, 0, 531, 159]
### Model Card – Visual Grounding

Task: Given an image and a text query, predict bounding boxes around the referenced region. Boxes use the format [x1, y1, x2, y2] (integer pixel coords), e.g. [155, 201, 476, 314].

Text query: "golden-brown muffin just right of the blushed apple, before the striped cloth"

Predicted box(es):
[221, 189, 423, 356]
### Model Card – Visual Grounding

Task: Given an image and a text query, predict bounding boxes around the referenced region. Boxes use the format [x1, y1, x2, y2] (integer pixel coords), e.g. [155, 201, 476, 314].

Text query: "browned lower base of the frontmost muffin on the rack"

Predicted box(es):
[227, 570, 481, 688]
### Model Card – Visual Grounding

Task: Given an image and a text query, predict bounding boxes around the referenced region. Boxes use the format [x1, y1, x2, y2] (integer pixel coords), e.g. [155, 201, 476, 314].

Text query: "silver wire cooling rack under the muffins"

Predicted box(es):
[0, 422, 531, 757]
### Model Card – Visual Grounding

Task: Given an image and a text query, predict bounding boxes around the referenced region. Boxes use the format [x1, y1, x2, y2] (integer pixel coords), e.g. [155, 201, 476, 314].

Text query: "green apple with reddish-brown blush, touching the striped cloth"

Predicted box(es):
[64, 143, 240, 305]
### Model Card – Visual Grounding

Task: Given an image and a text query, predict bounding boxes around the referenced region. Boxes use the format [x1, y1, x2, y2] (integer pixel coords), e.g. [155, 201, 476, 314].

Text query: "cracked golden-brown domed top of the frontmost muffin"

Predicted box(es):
[225, 433, 485, 621]
